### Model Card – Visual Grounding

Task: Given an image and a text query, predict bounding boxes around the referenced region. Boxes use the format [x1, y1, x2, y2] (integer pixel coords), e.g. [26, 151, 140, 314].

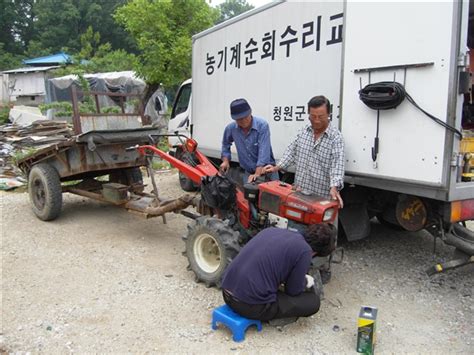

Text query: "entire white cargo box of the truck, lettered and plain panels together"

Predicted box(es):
[179, 1, 474, 200]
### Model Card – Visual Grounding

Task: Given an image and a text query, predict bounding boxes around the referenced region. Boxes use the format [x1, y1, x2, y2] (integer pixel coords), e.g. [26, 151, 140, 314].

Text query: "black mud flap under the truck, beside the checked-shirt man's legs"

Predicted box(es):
[339, 203, 370, 242]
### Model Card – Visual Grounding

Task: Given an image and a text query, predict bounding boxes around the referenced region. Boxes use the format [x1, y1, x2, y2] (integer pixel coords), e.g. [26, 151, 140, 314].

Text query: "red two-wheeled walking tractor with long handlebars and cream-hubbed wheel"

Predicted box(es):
[129, 138, 338, 287]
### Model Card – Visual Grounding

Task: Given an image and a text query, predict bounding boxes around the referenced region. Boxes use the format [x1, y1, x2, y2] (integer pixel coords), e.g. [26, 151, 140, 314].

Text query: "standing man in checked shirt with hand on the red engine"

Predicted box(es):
[264, 96, 344, 208]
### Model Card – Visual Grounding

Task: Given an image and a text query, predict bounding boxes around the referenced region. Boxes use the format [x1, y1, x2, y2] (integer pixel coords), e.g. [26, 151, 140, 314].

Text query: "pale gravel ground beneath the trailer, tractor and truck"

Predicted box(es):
[0, 172, 474, 354]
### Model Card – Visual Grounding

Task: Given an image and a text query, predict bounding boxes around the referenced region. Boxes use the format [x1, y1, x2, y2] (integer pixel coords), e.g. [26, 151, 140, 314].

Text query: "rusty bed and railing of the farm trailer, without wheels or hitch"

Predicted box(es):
[18, 86, 157, 181]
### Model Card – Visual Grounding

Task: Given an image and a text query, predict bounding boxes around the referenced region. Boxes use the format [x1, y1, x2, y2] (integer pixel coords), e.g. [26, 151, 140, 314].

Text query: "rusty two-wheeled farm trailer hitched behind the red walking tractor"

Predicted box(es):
[14, 87, 200, 222]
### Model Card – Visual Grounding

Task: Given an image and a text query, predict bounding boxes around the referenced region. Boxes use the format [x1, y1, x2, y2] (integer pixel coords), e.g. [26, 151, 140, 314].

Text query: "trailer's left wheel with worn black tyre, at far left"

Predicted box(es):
[28, 163, 63, 221]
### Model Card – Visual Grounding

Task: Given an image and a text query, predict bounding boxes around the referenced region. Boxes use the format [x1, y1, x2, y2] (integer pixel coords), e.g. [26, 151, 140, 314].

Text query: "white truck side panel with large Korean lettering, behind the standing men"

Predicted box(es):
[192, 2, 343, 163]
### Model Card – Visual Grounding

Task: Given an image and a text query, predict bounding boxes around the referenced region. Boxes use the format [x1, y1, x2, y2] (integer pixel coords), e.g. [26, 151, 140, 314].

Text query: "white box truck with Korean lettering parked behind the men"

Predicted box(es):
[169, 1, 474, 271]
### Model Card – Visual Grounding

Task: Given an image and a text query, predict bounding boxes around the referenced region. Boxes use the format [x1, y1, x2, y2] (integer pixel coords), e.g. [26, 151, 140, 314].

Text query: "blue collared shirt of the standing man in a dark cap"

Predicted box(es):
[221, 116, 275, 174]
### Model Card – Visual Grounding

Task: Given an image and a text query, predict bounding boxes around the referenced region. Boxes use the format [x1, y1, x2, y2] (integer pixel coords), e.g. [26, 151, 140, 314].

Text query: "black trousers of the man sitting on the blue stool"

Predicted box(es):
[222, 287, 321, 321]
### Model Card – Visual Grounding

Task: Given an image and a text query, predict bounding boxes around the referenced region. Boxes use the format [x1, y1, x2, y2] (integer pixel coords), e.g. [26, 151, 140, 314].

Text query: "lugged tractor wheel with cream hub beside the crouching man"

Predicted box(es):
[183, 217, 240, 287]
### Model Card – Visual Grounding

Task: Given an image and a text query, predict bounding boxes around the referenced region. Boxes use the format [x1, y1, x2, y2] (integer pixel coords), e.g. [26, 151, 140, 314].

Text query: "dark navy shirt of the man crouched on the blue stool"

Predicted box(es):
[222, 228, 312, 304]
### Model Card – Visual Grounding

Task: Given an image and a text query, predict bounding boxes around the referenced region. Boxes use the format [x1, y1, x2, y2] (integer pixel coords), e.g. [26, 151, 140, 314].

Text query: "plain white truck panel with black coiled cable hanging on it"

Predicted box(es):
[341, 2, 462, 197]
